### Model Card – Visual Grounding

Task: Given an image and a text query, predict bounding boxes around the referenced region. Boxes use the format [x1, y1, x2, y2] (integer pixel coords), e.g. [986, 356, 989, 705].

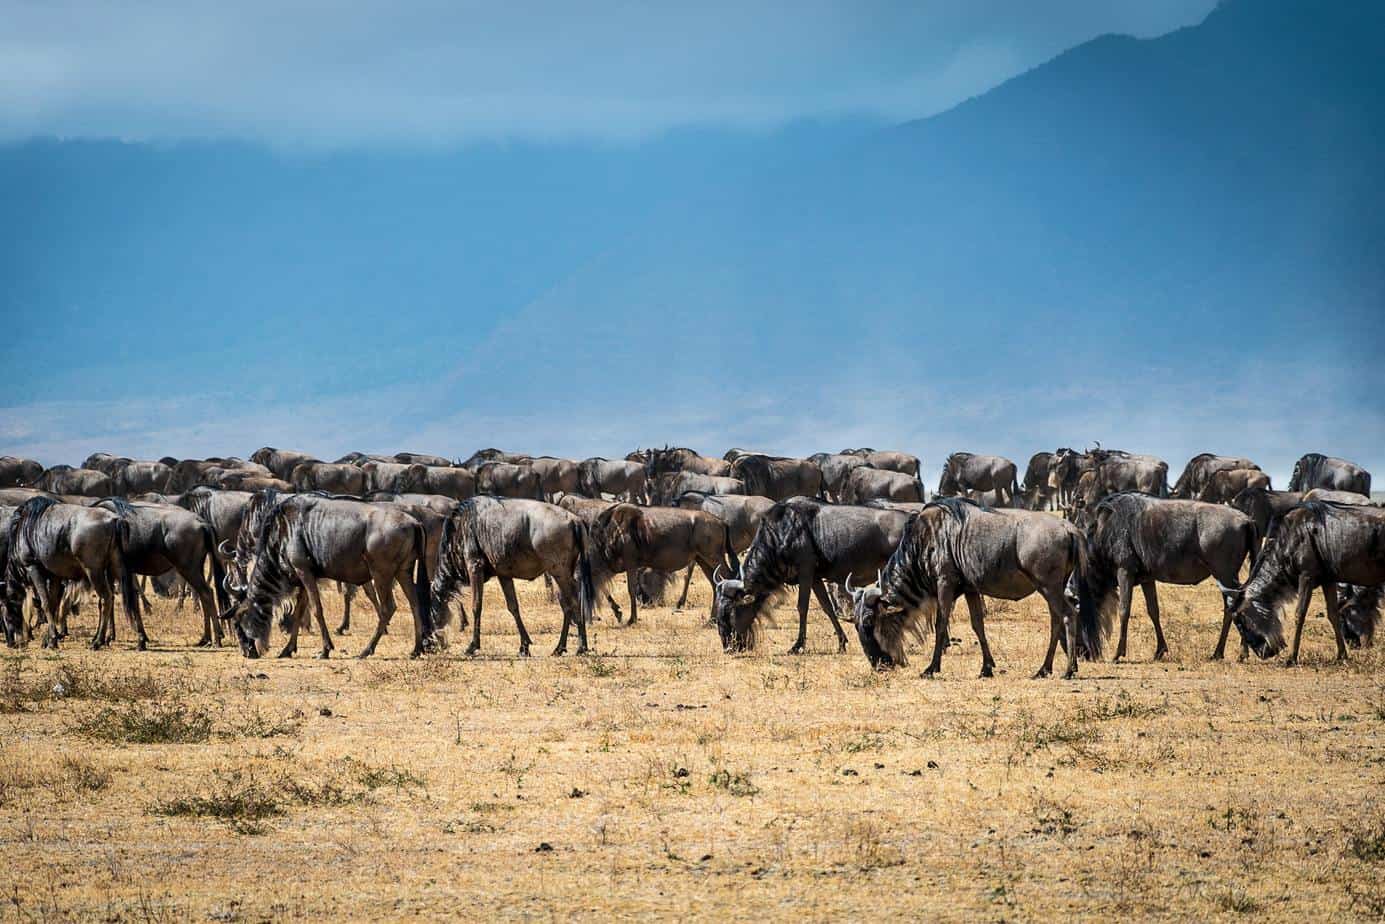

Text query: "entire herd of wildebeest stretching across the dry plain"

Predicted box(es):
[0, 446, 1385, 677]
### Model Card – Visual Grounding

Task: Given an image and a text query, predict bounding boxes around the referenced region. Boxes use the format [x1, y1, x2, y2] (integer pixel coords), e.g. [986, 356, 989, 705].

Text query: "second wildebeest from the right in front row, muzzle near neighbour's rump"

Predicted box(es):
[1083, 492, 1260, 661]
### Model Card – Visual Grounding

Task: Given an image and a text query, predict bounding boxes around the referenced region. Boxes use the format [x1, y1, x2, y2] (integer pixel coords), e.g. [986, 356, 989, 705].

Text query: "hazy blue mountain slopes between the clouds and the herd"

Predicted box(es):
[0, 0, 1385, 477]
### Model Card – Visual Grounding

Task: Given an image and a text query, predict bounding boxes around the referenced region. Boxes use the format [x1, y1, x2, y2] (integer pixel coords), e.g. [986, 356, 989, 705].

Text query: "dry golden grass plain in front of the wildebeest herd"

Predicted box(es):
[0, 585, 1385, 921]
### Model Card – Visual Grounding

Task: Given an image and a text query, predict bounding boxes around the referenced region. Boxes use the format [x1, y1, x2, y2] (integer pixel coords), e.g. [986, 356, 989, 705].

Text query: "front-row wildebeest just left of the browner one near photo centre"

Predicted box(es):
[432, 498, 598, 657]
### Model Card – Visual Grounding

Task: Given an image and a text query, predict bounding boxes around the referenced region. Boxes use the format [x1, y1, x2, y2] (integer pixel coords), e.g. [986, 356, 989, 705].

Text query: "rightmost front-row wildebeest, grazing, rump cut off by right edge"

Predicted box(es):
[1234, 500, 1385, 664]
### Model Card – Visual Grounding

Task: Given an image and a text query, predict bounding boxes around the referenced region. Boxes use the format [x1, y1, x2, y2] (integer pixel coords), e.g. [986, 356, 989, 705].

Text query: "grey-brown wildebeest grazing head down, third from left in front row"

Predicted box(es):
[223, 495, 432, 658]
